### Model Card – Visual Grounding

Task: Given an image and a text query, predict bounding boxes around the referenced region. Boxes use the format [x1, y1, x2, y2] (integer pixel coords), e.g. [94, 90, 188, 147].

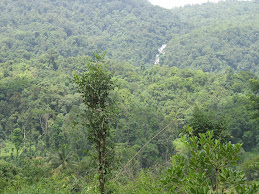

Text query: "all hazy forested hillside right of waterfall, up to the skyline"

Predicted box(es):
[162, 1, 259, 74]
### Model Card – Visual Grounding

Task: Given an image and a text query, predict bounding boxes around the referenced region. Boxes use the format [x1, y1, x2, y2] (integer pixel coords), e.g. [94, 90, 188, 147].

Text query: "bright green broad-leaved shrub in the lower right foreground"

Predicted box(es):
[162, 131, 257, 193]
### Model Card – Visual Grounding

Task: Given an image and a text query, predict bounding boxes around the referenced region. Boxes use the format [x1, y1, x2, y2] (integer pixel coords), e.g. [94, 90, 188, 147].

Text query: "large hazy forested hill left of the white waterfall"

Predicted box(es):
[0, 0, 187, 65]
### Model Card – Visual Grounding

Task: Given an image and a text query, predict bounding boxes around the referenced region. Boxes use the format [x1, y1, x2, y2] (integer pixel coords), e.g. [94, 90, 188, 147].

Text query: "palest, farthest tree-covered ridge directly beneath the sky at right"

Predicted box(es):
[172, 0, 258, 28]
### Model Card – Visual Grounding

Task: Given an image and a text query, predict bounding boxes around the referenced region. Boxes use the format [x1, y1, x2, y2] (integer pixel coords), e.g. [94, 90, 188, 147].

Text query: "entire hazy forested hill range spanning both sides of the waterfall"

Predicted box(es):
[0, 0, 259, 73]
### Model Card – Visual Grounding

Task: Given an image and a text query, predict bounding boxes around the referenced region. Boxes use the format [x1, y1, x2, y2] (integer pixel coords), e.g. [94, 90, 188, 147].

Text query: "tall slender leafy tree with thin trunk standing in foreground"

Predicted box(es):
[74, 53, 115, 193]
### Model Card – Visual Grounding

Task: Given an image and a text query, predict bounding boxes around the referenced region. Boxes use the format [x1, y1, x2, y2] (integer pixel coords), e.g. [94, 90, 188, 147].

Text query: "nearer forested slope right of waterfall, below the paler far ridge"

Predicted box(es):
[165, 21, 259, 73]
